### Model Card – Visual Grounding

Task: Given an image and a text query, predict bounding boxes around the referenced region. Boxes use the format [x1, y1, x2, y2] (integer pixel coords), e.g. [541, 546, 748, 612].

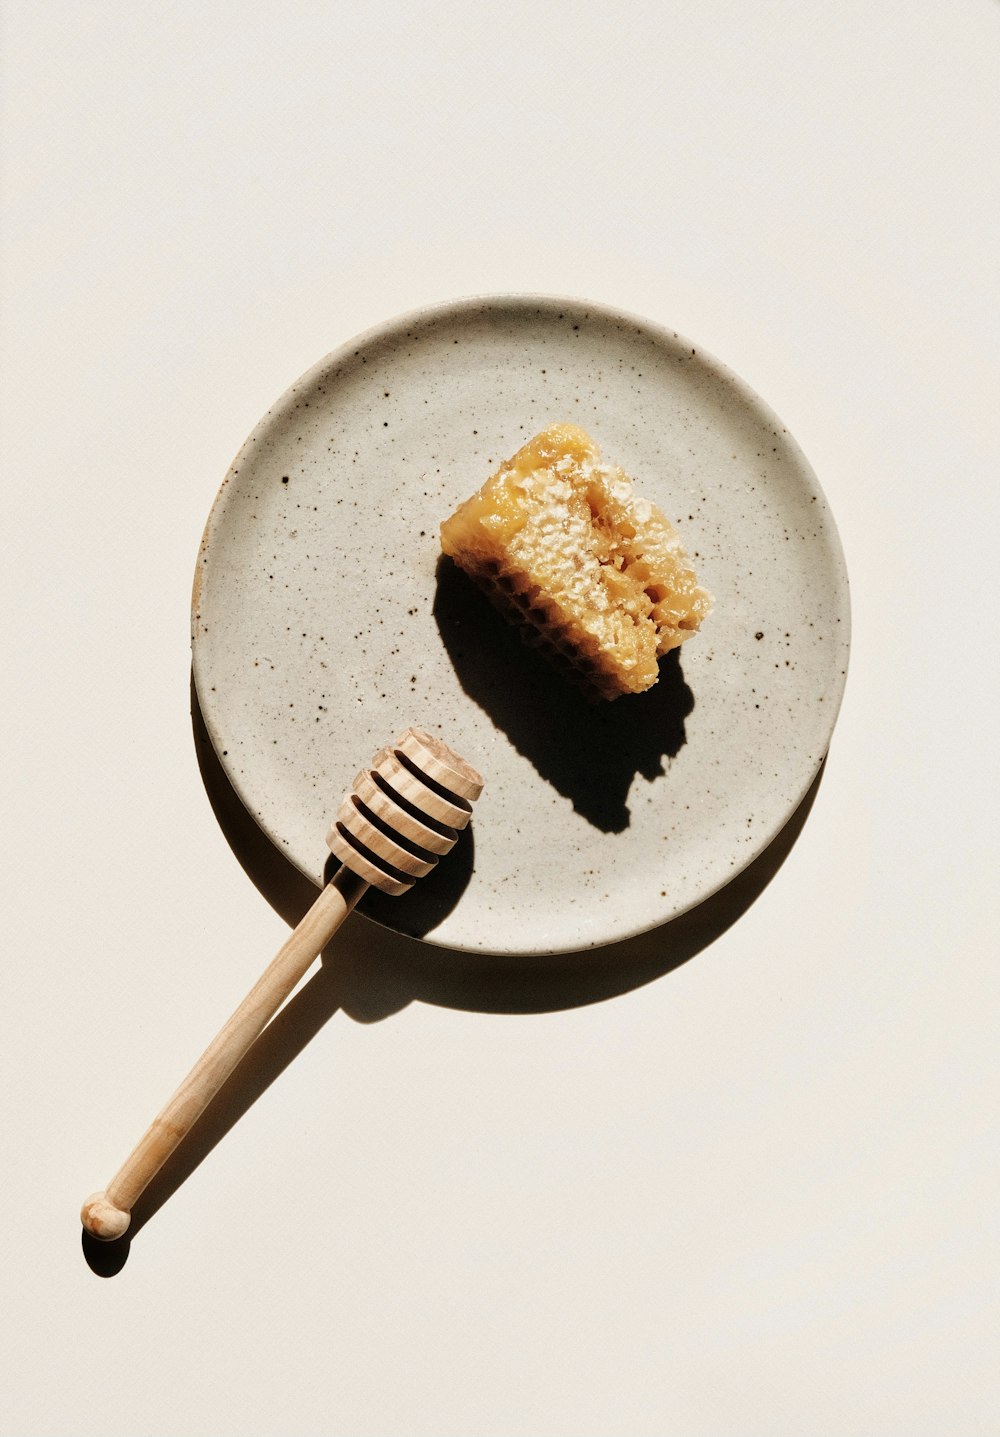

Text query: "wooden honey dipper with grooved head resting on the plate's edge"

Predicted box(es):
[80, 729, 483, 1242]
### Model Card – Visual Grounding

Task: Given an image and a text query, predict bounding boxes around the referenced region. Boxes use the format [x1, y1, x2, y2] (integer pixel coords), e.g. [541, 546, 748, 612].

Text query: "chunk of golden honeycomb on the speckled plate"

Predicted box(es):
[441, 424, 713, 698]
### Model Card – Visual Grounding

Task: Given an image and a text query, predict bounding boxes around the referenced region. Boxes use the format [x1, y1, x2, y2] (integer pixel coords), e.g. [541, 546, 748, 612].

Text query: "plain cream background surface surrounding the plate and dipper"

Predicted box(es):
[0, 0, 1000, 1437]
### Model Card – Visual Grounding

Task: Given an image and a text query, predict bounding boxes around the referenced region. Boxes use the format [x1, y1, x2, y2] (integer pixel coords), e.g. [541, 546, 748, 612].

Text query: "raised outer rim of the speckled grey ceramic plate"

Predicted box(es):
[190, 290, 852, 957]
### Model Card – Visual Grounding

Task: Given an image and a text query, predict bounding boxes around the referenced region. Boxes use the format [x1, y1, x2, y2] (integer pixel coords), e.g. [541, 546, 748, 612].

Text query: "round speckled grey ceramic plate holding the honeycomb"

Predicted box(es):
[193, 296, 849, 953]
